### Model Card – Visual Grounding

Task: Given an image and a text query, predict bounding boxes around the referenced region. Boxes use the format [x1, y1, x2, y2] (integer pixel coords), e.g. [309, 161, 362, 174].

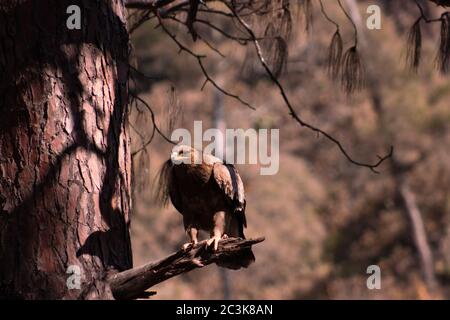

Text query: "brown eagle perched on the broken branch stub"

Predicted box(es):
[157, 145, 255, 269]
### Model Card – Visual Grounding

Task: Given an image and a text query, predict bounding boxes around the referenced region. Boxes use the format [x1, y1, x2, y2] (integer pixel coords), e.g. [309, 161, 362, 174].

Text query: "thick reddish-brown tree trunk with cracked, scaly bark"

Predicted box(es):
[0, 0, 132, 299]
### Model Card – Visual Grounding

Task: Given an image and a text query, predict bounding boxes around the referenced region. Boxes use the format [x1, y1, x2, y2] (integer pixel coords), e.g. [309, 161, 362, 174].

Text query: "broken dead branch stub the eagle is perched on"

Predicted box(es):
[109, 237, 265, 299]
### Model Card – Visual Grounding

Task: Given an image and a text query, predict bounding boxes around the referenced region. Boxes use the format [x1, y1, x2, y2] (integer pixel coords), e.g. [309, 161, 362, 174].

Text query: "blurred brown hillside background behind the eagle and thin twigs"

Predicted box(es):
[125, 0, 450, 299]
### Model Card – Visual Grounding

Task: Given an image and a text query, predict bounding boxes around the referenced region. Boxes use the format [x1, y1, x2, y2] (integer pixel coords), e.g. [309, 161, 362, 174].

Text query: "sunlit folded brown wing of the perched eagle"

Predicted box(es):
[213, 163, 247, 227]
